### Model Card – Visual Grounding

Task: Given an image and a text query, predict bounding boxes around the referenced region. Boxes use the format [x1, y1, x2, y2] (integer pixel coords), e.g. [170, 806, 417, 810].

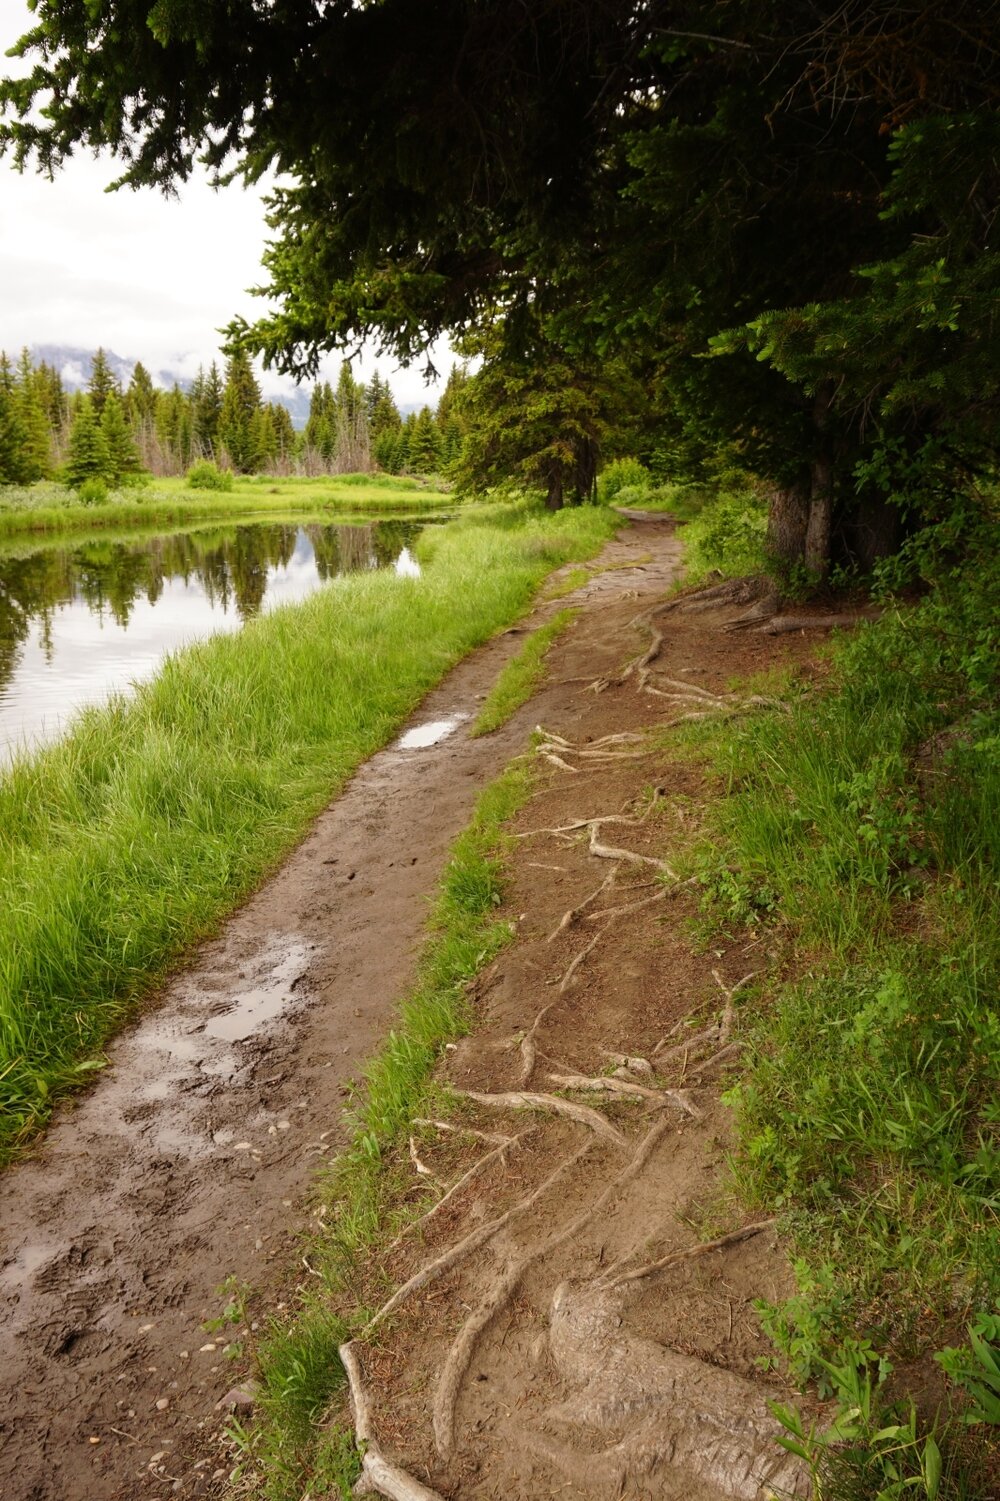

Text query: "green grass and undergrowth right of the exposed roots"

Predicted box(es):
[681, 536, 1000, 1496]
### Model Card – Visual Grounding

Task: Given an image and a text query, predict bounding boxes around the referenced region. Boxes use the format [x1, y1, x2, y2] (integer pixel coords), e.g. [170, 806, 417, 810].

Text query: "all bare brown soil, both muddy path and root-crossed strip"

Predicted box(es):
[0, 519, 821, 1501]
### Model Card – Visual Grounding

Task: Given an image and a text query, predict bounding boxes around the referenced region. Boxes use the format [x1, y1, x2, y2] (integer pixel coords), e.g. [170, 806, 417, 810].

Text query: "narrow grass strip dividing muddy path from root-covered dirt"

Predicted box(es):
[234, 761, 532, 1501]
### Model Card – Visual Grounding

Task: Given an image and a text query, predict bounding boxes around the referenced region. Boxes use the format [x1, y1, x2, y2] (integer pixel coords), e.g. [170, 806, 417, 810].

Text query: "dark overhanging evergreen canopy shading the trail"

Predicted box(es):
[0, 0, 1000, 570]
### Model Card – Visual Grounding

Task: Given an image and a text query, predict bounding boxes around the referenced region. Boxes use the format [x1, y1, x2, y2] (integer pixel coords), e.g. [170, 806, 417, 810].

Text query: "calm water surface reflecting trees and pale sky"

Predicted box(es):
[0, 519, 426, 764]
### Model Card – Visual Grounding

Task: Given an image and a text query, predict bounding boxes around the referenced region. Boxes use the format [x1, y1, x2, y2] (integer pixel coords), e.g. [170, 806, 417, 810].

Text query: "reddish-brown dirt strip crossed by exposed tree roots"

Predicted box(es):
[325, 549, 817, 1501]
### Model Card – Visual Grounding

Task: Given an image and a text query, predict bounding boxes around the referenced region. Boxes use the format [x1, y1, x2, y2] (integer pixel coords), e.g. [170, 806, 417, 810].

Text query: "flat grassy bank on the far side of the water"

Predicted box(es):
[0, 474, 449, 537]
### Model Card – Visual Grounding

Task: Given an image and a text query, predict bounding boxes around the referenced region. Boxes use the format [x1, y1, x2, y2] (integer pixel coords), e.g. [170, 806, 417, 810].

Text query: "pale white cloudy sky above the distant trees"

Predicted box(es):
[0, 0, 447, 404]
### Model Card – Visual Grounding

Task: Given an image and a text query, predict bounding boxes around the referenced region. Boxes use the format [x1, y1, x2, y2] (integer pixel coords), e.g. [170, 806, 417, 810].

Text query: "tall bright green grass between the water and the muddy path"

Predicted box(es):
[0, 506, 613, 1157]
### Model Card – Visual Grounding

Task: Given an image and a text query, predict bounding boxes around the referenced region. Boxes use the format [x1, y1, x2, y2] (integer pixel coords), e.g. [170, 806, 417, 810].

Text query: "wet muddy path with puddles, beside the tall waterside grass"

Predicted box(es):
[0, 521, 679, 1501]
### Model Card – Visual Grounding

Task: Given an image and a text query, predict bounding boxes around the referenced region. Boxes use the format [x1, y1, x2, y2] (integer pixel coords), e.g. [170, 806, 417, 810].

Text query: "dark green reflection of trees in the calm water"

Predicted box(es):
[0, 521, 422, 689]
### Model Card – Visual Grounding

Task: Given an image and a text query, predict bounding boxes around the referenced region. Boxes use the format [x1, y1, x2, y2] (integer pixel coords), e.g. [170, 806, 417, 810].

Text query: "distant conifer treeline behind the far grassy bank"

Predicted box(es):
[0, 350, 467, 488]
